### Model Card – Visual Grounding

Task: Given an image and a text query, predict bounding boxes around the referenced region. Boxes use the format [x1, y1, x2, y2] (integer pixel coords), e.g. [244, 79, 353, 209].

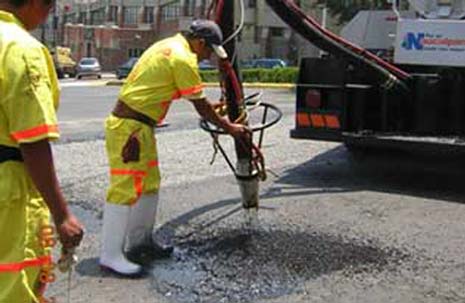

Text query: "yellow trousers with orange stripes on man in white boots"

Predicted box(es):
[105, 115, 160, 205]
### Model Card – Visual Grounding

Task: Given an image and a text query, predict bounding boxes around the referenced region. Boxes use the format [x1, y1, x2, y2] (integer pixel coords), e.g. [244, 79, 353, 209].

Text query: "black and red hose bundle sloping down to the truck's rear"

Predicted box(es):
[266, 0, 411, 90]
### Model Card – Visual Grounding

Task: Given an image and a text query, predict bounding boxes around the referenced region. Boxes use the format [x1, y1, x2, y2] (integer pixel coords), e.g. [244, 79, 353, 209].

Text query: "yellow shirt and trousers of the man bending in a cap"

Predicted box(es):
[105, 34, 205, 205]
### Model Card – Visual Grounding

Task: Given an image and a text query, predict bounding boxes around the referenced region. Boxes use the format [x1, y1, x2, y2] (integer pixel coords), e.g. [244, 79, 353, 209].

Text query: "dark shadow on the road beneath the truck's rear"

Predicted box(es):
[261, 146, 465, 203]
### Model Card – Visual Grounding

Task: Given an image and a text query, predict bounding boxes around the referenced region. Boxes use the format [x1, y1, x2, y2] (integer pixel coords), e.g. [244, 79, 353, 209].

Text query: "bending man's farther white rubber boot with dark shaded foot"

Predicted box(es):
[126, 194, 173, 257]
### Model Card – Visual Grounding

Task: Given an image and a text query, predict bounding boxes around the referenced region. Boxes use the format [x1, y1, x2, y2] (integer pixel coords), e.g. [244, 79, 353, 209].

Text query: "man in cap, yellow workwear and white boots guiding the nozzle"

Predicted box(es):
[100, 20, 248, 275]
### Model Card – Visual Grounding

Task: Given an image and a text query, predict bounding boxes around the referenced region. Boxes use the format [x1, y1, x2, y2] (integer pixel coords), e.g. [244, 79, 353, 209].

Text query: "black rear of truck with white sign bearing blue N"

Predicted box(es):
[266, 0, 465, 153]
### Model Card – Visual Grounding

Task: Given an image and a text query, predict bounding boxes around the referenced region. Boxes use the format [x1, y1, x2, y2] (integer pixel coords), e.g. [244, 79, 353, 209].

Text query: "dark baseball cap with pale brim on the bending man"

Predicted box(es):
[189, 19, 228, 59]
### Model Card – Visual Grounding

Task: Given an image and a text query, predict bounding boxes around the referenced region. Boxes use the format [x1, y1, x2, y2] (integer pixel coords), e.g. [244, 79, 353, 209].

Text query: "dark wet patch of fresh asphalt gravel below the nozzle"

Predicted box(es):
[152, 227, 409, 303]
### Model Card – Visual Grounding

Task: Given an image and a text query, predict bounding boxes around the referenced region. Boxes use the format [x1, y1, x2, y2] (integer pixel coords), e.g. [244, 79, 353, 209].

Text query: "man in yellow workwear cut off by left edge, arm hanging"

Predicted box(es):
[0, 0, 83, 303]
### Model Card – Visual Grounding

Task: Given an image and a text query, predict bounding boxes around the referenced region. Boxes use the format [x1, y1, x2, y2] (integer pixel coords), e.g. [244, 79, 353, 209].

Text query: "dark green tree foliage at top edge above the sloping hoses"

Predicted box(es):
[317, 0, 391, 24]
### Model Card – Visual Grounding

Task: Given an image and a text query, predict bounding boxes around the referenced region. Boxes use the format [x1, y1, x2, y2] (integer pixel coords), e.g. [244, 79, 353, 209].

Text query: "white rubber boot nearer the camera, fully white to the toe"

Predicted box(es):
[100, 202, 142, 276]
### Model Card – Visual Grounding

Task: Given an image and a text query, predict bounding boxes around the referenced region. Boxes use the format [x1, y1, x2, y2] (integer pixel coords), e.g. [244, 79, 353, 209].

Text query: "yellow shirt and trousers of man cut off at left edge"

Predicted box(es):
[0, 10, 59, 303]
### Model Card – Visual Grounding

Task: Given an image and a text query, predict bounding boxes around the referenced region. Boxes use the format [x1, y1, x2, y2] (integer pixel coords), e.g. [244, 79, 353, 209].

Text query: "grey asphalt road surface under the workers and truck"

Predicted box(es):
[48, 82, 465, 303]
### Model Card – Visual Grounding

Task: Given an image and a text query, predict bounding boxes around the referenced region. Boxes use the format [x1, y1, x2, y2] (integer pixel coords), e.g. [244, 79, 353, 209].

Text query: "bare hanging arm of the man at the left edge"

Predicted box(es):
[19, 139, 83, 248]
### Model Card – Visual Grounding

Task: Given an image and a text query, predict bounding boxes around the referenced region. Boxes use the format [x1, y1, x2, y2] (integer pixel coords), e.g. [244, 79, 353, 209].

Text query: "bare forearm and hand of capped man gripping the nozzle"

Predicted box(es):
[190, 98, 250, 139]
